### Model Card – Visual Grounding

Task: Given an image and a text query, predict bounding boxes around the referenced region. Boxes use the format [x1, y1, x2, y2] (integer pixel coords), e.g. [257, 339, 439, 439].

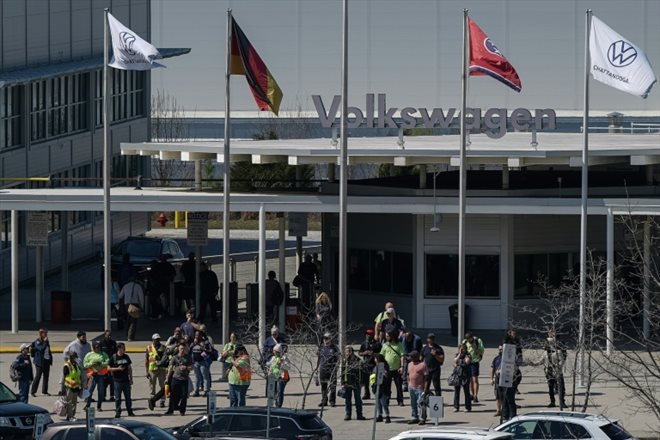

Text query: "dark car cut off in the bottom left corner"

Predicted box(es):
[0, 382, 53, 440]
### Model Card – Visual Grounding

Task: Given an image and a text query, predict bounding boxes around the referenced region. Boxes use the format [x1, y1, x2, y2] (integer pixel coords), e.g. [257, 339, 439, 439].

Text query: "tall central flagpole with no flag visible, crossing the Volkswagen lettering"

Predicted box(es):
[337, 0, 348, 350]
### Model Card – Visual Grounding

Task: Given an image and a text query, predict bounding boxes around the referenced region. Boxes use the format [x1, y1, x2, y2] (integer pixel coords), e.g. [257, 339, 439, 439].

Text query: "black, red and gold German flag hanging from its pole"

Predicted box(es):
[229, 17, 282, 115]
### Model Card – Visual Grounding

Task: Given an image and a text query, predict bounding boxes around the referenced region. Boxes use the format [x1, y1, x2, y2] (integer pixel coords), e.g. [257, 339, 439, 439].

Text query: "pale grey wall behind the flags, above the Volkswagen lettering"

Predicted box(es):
[152, 0, 660, 116]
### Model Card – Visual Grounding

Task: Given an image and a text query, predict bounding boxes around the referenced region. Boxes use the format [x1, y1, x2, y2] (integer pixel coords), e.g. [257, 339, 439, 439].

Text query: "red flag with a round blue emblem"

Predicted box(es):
[468, 18, 522, 92]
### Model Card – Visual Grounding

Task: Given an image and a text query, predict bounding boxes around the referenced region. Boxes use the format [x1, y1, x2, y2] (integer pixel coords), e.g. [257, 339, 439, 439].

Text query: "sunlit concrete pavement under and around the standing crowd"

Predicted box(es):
[0, 336, 660, 439]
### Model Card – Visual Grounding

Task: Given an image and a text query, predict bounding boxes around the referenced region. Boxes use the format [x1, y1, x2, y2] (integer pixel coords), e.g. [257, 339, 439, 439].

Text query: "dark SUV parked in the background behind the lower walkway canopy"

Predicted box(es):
[101, 237, 184, 285]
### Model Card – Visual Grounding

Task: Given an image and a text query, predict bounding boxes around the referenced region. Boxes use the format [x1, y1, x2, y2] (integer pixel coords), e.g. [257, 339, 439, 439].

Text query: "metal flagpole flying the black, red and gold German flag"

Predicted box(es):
[222, 9, 232, 348]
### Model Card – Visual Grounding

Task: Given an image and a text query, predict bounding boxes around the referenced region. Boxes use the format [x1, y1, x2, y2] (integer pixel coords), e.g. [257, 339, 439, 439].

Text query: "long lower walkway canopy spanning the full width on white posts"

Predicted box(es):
[0, 188, 660, 215]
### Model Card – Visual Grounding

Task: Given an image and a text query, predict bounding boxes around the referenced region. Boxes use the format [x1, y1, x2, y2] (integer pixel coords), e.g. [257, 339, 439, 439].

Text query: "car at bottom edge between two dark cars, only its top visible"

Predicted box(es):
[41, 419, 176, 440]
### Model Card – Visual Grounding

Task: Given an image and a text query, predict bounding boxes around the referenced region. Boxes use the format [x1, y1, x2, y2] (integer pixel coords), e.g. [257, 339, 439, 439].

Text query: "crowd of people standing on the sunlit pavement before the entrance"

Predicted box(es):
[11, 298, 567, 424]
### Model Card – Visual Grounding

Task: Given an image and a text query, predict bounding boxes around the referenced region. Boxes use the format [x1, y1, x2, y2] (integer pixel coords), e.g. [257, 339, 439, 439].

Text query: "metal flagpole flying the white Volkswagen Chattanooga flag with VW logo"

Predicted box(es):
[578, 9, 592, 386]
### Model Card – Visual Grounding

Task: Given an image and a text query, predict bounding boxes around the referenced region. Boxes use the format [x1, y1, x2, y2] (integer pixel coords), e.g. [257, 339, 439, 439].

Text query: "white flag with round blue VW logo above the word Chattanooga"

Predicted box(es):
[589, 17, 657, 98]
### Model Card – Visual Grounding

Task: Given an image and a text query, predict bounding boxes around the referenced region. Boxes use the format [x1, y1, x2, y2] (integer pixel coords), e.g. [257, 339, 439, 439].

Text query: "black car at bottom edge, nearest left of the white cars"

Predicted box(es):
[171, 406, 332, 440]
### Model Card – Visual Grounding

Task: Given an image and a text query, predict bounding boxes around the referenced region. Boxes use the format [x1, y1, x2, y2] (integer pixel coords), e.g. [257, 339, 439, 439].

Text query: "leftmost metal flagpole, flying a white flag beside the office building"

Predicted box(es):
[103, 8, 112, 329]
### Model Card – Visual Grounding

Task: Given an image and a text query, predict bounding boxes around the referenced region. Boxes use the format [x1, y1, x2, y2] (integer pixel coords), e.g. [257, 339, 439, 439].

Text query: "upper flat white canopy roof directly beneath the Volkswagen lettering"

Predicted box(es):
[121, 132, 660, 168]
